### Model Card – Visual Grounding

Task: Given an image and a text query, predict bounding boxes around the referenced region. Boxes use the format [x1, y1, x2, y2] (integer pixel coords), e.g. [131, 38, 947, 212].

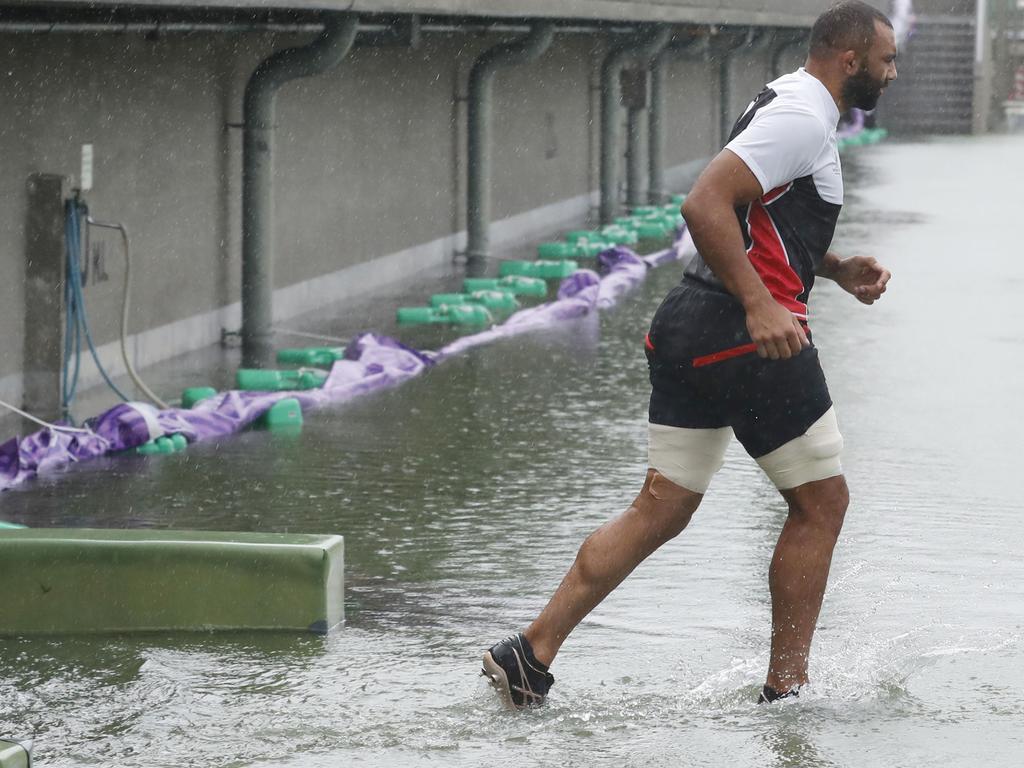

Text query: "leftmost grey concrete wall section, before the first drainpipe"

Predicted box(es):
[0, 31, 225, 392]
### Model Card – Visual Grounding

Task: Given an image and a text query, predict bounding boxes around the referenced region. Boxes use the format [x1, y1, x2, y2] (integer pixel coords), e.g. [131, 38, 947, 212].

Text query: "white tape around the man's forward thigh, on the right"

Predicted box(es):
[757, 408, 843, 490]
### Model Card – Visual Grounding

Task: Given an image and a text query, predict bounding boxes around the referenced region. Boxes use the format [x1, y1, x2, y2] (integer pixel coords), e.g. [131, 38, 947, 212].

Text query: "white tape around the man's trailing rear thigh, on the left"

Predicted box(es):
[647, 424, 732, 494]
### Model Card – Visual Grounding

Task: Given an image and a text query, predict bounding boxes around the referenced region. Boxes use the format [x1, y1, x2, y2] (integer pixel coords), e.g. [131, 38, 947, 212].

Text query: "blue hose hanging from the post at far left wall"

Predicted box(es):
[61, 200, 129, 418]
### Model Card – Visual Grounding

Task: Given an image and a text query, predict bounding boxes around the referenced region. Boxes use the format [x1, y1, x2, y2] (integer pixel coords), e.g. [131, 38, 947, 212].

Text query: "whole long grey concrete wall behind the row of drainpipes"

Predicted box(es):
[0, 20, 798, 411]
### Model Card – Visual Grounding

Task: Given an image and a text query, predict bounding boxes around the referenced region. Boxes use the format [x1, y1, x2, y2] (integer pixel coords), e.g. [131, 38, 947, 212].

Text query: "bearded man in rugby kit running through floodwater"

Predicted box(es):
[483, 0, 896, 708]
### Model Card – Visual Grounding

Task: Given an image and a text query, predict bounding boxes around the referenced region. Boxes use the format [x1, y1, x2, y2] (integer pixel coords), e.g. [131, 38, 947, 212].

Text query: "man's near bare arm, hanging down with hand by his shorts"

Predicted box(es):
[682, 150, 810, 360]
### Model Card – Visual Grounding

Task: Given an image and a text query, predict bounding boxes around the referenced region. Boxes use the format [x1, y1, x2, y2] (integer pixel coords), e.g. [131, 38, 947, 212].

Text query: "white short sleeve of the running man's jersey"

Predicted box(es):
[725, 104, 828, 194]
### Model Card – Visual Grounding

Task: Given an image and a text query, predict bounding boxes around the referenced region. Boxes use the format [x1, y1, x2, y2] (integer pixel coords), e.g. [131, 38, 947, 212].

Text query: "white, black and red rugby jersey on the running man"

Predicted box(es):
[684, 68, 843, 319]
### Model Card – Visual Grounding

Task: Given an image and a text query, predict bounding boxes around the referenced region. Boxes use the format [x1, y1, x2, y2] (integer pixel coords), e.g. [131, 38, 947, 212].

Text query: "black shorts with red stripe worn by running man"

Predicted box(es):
[645, 278, 831, 459]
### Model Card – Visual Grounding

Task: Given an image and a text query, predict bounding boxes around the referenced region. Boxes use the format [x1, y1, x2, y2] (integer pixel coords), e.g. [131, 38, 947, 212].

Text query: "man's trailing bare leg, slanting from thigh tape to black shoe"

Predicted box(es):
[523, 469, 703, 665]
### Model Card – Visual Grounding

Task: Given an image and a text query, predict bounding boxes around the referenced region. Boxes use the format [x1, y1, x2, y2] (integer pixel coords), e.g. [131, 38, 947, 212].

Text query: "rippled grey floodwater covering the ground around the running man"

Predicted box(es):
[0, 137, 1024, 768]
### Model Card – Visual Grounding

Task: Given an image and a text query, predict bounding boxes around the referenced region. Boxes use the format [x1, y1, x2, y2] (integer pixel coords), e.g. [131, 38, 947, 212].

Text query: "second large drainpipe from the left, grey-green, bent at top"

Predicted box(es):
[466, 22, 555, 265]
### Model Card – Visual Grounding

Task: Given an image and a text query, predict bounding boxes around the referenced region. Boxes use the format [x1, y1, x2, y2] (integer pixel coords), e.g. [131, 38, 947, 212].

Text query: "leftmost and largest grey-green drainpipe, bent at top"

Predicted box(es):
[242, 14, 359, 368]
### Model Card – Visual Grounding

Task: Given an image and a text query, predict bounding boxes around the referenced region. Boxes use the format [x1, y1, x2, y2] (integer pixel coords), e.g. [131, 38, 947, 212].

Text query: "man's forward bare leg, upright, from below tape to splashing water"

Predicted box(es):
[767, 475, 850, 693]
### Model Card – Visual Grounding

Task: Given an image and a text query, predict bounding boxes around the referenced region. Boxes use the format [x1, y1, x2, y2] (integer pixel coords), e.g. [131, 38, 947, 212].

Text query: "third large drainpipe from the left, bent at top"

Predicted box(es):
[600, 27, 672, 224]
